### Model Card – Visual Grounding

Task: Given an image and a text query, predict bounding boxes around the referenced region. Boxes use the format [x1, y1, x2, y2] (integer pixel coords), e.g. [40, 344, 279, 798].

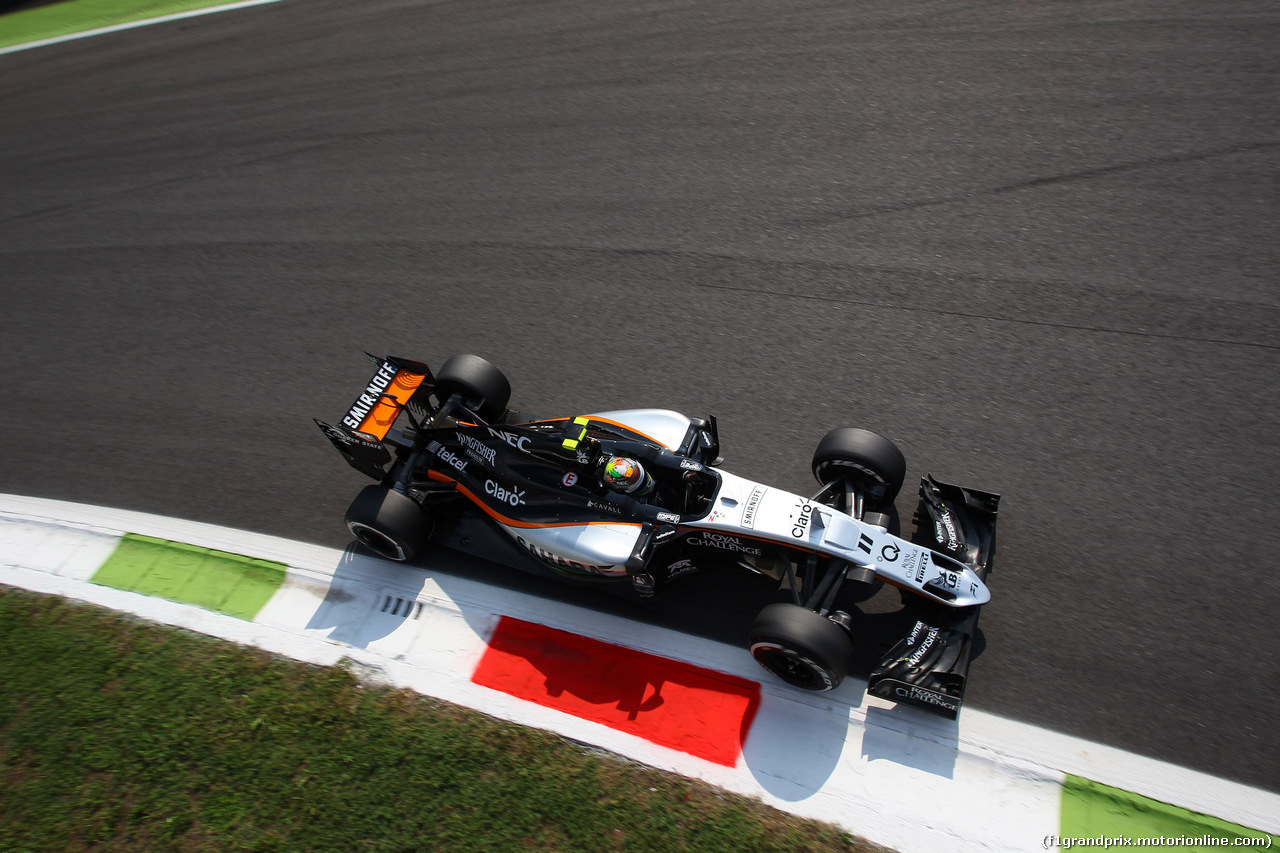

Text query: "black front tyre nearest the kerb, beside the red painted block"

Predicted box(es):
[749, 602, 854, 692]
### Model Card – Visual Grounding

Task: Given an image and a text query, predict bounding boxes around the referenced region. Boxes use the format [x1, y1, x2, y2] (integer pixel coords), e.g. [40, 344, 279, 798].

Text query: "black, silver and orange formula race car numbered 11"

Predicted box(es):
[316, 355, 1000, 719]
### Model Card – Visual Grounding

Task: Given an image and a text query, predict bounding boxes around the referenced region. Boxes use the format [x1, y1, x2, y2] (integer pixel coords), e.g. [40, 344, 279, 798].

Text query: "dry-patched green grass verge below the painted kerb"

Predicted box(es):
[0, 588, 890, 853]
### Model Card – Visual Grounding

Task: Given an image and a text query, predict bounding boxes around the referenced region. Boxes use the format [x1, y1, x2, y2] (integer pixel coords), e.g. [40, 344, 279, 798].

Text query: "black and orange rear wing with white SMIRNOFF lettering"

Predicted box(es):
[316, 355, 435, 480]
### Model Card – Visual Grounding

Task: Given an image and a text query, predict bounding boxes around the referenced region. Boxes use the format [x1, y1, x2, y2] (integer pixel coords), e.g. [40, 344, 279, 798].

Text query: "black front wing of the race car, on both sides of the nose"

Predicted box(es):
[867, 476, 1000, 720]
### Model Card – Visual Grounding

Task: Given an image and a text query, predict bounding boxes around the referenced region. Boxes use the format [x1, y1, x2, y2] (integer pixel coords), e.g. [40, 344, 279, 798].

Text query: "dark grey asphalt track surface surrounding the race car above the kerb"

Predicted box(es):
[0, 0, 1280, 790]
